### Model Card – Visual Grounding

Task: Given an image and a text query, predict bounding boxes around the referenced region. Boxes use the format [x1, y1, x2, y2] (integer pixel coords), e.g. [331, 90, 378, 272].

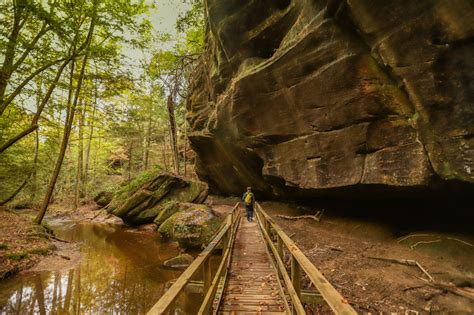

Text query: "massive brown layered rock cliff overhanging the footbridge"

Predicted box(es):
[187, 0, 474, 197]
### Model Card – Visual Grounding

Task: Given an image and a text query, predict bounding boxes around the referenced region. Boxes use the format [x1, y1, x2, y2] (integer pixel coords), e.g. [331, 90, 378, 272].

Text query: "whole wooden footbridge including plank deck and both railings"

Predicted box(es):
[147, 203, 357, 315]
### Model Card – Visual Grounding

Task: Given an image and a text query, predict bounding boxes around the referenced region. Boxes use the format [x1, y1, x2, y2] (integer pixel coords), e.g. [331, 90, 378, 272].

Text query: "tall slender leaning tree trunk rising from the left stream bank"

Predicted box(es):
[36, 7, 96, 224]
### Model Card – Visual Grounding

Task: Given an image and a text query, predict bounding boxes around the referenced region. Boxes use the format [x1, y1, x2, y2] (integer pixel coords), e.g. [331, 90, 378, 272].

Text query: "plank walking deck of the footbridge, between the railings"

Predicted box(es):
[219, 218, 288, 314]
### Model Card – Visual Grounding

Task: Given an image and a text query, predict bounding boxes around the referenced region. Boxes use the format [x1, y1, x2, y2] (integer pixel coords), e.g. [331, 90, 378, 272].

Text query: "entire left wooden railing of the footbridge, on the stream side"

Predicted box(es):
[147, 203, 240, 314]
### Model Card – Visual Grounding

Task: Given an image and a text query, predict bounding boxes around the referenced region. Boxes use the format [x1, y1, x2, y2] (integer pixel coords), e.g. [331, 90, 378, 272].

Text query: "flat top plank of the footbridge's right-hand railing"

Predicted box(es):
[257, 203, 357, 314]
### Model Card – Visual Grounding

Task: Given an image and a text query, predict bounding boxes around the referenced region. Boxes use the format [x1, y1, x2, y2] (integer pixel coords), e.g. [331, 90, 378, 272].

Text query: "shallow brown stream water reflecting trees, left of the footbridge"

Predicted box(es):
[0, 221, 195, 314]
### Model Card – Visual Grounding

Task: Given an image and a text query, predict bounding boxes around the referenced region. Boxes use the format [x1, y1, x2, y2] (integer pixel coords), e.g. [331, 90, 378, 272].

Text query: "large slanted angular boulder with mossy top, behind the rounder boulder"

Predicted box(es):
[108, 174, 208, 225]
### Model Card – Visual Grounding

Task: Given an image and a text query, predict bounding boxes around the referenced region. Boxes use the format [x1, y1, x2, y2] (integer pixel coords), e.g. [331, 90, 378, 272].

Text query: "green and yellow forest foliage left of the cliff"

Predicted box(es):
[0, 0, 204, 204]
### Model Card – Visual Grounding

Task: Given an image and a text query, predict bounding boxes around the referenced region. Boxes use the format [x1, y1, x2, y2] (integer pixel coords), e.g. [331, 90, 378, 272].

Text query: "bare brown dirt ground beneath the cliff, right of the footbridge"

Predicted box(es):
[208, 197, 474, 314]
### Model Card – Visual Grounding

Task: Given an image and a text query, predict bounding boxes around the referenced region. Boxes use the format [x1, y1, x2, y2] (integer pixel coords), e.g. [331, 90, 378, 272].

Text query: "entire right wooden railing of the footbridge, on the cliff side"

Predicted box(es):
[256, 203, 357, 314]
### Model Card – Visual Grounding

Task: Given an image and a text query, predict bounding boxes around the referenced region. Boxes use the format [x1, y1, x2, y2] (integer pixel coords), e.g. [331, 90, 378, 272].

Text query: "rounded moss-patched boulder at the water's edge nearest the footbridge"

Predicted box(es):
[158, 204, 220, 249]
